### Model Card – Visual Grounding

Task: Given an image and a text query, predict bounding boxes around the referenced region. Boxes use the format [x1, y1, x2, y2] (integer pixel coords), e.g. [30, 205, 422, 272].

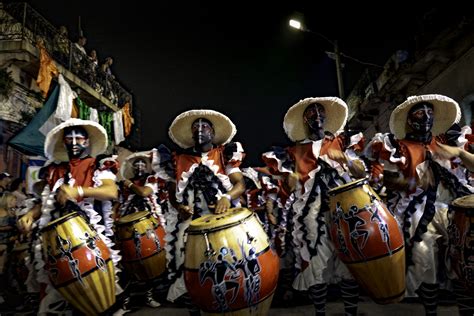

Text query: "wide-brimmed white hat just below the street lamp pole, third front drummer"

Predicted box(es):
[283, 97, 348, 142]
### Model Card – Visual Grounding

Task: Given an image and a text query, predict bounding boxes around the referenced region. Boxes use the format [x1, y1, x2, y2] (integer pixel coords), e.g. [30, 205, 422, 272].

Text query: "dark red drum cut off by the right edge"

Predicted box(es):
[448, 195, 474, 297]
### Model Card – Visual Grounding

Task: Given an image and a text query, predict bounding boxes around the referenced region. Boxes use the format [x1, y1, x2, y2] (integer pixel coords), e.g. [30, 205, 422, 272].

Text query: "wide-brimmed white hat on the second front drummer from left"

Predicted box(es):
[168, 110, 237, 148]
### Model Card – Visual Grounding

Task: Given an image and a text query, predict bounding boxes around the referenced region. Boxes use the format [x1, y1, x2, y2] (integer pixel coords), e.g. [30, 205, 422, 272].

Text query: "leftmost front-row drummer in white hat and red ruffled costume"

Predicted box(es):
[18, 119, 122, 314]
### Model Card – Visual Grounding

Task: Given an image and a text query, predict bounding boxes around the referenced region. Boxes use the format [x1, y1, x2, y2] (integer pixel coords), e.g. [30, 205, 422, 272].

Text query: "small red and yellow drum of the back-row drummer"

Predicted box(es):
[116, 211, 166, 280]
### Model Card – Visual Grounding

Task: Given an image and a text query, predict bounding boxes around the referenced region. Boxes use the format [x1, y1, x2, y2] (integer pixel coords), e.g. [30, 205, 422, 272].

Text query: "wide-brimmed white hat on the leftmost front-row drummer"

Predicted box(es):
[44, 118, 108, 161]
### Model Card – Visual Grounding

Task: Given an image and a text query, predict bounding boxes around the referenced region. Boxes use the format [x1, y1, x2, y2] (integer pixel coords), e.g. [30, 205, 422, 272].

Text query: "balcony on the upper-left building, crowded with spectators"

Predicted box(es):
[0, 3, 132, 111]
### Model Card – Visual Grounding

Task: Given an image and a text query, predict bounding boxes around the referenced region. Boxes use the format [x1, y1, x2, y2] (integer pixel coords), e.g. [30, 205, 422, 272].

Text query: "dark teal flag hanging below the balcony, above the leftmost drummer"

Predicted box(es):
[8, 86, 59, 157]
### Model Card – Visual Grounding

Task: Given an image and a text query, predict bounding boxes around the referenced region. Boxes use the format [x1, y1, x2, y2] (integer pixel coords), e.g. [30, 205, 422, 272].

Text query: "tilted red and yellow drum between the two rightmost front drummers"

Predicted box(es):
[329, 179, 405, 304]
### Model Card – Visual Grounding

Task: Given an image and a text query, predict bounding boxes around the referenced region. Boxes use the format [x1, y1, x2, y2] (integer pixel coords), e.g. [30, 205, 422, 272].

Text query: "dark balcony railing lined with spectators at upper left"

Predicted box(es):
[0, 3, 132, 107]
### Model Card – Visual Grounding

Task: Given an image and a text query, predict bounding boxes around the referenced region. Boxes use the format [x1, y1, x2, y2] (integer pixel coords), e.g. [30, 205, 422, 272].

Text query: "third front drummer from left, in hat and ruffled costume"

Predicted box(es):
[262, 97, 365, 315]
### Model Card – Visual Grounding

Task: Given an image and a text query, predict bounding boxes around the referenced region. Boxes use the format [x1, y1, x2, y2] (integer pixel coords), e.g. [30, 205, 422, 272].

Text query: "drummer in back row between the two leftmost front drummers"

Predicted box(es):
[119, 151, 165, 311]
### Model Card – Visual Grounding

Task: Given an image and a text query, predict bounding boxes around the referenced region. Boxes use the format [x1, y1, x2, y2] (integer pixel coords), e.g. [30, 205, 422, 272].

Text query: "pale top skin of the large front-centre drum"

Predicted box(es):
[187, 208, 253, 232]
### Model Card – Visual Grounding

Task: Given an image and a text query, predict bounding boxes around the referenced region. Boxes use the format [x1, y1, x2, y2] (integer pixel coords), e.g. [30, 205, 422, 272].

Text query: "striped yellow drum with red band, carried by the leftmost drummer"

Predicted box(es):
[42, 212, 115, 315]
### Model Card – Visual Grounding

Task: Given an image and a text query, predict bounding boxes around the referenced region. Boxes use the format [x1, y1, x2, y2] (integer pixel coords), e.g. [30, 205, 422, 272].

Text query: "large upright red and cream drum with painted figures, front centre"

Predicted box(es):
[184, 208, 279, 315]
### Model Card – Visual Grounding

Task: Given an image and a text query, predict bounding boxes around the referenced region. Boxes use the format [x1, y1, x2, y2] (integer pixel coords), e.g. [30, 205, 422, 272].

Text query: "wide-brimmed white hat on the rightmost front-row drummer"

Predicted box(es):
[390, 94, 461, 139]
